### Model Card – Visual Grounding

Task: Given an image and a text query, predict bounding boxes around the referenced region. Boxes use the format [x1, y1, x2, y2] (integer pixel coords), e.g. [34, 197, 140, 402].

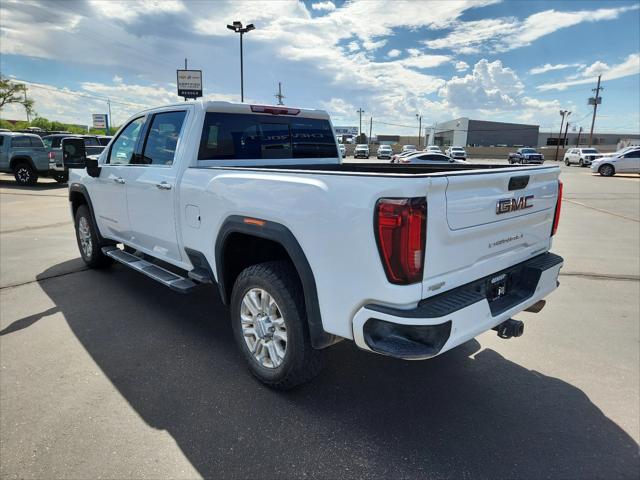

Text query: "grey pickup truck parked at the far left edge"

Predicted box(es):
[0, 132, 53, 185]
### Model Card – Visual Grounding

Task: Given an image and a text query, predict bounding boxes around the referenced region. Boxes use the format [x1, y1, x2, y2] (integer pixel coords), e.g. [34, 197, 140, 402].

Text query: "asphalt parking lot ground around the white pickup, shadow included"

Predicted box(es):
[0, 165, 640, 479]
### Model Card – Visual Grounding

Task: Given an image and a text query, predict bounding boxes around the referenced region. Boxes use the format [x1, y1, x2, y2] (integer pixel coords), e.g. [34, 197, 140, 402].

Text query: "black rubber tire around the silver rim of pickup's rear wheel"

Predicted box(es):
[231, 261, 322, 390]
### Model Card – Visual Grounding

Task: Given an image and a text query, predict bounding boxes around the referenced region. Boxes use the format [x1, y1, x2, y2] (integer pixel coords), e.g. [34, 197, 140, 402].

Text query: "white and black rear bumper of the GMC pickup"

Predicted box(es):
[353, 253, 563, 360]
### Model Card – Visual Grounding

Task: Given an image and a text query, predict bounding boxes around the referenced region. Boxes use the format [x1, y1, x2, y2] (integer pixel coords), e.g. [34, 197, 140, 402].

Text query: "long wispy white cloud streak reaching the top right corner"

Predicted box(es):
[423, 5, 640, 54]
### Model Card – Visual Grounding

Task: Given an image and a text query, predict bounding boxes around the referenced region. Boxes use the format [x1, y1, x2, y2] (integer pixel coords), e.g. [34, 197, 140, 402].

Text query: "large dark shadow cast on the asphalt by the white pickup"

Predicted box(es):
[40, 265, 640, 478]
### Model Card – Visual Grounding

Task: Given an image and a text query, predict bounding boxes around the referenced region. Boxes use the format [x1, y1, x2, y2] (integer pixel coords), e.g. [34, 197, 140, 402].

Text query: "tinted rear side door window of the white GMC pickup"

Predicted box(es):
[142, 112, 186, 165]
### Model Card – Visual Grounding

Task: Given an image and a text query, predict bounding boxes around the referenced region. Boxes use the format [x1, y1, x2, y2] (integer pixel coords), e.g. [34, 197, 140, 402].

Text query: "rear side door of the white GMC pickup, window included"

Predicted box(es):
[126, 110, 187, 262]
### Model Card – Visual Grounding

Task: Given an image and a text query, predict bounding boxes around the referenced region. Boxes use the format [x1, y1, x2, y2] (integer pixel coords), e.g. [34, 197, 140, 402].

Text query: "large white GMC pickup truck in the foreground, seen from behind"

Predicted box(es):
[64, 102, 562, 389]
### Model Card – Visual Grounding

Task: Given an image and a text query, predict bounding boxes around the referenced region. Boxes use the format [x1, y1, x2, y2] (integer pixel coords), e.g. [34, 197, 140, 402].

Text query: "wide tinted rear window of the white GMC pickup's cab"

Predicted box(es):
[198, 113, 338, 160]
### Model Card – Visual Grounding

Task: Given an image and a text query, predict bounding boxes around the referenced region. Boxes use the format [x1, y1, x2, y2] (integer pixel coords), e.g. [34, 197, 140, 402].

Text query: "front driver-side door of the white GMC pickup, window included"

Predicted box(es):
[89, 117, 145, 243]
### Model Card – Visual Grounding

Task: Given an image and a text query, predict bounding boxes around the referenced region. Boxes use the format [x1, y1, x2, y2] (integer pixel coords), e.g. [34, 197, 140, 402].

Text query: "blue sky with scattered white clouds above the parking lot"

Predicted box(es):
[0, 0, 640, 134]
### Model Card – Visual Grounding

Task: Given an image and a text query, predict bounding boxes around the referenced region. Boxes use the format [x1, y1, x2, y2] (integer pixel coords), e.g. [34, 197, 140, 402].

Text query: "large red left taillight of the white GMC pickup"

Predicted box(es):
[375, 197, 427, 285]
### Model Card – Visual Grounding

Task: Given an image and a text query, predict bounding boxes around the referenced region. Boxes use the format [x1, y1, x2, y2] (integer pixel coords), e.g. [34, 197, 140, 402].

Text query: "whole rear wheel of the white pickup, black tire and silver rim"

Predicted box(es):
[231, 261, 322, 390]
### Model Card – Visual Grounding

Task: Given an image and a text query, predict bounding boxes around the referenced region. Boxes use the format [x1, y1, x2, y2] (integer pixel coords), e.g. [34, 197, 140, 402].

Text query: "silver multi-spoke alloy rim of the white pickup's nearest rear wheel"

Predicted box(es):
[240, 288, 287, 368]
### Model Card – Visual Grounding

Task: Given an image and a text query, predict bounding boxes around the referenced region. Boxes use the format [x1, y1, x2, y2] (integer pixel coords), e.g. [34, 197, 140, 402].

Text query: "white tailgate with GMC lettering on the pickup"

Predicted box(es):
[423, 167, 559, 297]
